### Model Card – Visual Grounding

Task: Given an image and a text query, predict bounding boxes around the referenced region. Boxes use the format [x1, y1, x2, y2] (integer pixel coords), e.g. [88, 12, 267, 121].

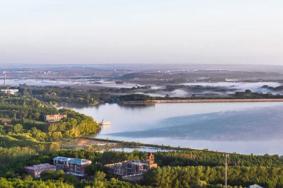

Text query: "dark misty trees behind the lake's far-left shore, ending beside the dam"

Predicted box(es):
[29, 86, 154, 106]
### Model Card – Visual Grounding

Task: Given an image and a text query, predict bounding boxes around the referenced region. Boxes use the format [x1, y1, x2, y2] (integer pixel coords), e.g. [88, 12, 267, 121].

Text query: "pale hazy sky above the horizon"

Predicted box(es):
[0, 0, 283, 65]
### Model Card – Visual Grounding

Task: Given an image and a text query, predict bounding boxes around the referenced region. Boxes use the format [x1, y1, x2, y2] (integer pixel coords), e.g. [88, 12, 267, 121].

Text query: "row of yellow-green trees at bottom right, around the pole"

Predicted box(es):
[145, 166, 283, 188]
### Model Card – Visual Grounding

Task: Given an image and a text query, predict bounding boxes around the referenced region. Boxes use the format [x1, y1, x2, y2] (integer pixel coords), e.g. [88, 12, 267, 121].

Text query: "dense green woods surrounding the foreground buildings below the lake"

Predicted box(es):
[0, 147, 283, 188]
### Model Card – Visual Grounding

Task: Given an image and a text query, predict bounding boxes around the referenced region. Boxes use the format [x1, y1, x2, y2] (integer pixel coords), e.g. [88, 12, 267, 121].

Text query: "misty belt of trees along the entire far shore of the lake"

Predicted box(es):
[13, 85, 283, 107]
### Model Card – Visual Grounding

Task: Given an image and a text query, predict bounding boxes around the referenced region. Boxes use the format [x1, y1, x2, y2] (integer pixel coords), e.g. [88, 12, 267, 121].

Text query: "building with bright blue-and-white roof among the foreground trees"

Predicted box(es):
[53, 156, 92, 177]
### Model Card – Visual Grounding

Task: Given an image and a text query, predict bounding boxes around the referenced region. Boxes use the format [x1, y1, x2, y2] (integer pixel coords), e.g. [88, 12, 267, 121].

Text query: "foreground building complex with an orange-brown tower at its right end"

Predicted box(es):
[105, 153, 158, 181]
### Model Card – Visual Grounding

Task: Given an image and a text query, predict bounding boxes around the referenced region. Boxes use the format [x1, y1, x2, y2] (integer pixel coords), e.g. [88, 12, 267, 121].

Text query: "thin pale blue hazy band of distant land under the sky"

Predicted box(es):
[0, 63, 283, 73]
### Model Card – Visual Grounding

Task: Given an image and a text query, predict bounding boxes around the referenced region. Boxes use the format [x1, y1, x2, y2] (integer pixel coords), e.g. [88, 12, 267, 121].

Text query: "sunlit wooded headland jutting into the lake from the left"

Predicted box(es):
[0, 95, 100, 142]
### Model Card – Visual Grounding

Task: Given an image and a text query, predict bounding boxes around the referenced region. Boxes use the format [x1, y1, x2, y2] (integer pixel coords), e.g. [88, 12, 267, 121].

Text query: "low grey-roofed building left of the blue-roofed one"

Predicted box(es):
[25, 163, 56, 178]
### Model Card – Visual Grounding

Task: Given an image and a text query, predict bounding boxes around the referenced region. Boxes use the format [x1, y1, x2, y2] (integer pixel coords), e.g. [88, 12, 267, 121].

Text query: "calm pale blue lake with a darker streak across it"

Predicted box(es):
[74, 103, 283, 154]
